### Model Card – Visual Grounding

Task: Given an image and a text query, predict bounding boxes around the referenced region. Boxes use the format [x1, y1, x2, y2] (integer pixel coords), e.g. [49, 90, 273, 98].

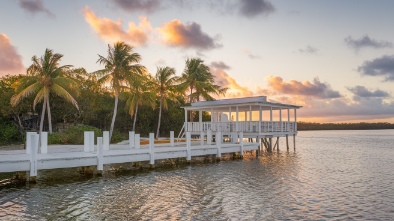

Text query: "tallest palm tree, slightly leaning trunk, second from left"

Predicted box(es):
[93, 42, 144, 140]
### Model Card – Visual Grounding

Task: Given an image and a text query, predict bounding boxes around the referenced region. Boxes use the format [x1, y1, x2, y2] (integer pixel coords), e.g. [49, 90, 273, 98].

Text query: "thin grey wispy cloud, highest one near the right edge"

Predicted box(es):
[344, 35, 393, 51]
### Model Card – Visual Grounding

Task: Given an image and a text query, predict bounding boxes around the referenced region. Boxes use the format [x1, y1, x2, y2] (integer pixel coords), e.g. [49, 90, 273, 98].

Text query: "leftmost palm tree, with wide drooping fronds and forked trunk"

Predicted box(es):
[11, 49, 78, 134]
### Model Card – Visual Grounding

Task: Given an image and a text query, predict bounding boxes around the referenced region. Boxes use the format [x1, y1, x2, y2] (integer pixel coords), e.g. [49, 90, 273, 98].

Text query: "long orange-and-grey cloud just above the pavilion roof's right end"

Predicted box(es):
[267, 76, 341, 99]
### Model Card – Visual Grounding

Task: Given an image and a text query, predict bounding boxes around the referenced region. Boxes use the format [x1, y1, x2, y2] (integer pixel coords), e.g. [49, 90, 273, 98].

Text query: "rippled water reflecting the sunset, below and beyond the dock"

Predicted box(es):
[0, 130, 394, 220]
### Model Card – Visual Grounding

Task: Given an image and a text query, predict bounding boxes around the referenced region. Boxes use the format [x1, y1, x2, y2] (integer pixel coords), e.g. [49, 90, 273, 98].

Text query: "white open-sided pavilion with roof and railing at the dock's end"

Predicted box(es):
[183, 96, 301, 150]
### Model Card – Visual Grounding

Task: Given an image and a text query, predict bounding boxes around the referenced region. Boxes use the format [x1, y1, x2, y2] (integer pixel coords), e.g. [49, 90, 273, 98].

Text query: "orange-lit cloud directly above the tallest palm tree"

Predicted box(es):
[84, 6, 152, 46]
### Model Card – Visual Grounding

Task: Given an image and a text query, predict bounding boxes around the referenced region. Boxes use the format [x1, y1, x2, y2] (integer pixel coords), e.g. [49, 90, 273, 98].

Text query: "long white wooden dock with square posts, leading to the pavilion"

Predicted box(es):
[0, 131, 259, 177]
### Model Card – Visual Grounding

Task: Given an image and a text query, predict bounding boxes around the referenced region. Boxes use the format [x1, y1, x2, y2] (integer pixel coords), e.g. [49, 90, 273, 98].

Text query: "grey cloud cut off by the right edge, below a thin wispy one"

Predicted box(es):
[357, 55, 394, 81]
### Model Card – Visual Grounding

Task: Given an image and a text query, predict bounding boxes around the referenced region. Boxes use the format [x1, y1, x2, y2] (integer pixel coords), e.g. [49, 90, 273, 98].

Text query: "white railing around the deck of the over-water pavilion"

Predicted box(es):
[185, 121, 297, 133]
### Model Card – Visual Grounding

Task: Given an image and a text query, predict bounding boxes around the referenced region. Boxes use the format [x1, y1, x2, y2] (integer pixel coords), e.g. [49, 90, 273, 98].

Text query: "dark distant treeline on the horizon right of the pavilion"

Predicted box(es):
[297, 122, 394, 130]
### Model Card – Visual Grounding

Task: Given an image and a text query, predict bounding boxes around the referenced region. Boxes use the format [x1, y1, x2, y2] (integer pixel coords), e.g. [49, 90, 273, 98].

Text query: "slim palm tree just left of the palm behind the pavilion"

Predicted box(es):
[156, 67, 179, 139]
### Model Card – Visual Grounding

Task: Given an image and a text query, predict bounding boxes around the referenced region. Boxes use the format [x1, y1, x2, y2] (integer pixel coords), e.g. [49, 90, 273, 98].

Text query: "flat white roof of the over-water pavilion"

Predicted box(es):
[183, 96, 302, 111]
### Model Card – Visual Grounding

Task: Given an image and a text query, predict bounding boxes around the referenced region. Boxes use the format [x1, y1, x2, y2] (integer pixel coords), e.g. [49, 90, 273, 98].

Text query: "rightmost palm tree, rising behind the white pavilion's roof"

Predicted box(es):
[180, 58, 228, 121]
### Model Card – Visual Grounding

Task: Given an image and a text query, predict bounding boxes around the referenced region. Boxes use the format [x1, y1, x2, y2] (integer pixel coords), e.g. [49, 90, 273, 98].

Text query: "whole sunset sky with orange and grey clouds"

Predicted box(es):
[0, 0, 394, 123]
